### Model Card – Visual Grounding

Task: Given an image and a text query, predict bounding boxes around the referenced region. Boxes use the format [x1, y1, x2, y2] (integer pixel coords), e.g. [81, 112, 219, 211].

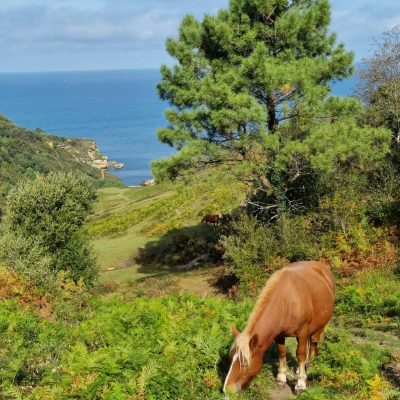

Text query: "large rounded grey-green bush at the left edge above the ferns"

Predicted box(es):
[0, 173, 96, 285]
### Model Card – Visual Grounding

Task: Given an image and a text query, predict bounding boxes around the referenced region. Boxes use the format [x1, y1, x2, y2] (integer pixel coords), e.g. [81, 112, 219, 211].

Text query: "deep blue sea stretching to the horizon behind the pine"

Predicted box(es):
[0, 69, 355, 186]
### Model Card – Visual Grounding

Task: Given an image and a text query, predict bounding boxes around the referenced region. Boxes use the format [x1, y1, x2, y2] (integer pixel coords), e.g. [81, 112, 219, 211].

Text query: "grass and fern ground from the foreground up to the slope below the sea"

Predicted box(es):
[0, 172, 400, 400]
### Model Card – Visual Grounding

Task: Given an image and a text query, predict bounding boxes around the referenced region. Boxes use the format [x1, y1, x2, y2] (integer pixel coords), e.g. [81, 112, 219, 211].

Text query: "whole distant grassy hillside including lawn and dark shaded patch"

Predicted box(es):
[89, 167, 247, 284]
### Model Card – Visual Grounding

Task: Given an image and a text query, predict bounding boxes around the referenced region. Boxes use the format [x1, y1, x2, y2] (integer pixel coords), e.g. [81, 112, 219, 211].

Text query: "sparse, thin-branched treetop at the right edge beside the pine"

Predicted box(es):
[357, 25, 400, 143]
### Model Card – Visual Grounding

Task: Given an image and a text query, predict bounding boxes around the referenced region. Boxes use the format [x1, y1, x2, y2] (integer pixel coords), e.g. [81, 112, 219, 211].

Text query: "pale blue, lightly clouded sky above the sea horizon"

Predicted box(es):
[0, 0, 400, 72]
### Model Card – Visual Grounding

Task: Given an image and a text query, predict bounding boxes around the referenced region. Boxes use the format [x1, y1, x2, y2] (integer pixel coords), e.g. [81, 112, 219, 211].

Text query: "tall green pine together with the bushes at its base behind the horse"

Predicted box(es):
[153, 0, 399, 302]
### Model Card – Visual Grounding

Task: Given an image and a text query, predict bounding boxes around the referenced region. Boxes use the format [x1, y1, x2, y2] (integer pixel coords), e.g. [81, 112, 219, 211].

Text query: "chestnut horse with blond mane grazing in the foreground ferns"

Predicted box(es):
[223, 261, 335, 392]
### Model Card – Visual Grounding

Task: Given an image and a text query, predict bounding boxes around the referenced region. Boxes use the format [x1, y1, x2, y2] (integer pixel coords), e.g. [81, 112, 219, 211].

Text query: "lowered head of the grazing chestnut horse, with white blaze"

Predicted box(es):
[223, 327, 263, 393]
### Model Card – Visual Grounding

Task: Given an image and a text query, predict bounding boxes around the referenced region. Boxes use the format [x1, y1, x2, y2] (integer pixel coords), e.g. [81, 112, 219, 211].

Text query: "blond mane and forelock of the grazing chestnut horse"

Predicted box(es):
[231, 268, 286, 366]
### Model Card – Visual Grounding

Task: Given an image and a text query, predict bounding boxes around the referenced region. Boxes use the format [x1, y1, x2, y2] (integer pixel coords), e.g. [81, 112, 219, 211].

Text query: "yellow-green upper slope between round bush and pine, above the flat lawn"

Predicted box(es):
[89, 167, 246, 238]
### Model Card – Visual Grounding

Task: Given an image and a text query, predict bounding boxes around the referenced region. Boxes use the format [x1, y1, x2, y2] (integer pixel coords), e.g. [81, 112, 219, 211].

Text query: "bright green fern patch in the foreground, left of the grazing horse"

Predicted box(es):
[0, 296, 249, 399]
